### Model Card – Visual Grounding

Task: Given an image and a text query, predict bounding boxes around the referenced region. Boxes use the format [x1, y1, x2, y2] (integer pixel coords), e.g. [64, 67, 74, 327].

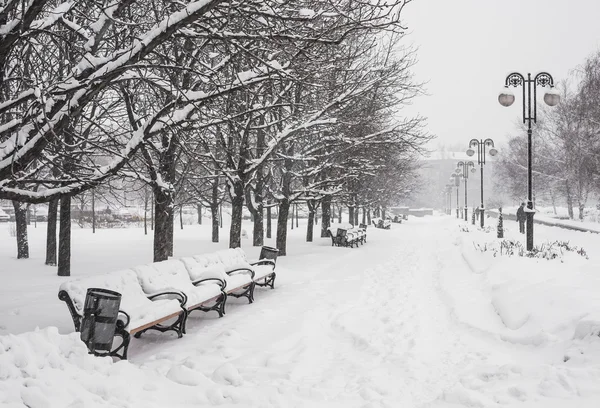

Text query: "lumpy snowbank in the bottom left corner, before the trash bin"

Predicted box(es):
[0, 327, 262, 408]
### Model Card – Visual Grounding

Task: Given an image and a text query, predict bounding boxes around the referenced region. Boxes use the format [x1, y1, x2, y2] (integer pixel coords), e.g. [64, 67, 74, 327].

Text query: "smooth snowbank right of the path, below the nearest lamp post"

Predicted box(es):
[462, 233, 600, 345]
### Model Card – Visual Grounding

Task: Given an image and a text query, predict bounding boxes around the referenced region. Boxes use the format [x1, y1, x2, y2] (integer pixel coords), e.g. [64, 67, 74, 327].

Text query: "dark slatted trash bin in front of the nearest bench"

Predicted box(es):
[81, 288, 121, 355]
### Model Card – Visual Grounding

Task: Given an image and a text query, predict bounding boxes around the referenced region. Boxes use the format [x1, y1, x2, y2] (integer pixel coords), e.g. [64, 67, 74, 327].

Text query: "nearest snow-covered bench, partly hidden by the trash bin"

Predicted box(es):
[58, 269, 187, 359]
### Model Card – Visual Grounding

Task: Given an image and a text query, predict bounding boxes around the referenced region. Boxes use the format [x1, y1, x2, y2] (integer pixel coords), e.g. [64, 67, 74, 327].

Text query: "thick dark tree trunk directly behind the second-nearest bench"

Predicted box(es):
[154, 187, 173, 262]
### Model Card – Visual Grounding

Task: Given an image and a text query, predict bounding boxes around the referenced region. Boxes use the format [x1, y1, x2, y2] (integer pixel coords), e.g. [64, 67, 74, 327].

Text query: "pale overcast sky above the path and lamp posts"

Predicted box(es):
[404, 0, 600, 149]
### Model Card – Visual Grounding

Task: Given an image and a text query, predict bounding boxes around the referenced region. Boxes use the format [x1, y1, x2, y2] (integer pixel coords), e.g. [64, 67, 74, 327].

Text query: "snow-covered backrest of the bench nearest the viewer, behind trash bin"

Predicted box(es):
[60, 269, 150, 315]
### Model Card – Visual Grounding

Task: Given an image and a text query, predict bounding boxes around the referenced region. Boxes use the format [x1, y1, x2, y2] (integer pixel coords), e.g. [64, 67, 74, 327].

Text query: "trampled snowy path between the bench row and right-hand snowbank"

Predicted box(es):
[125, 221, 492, 407]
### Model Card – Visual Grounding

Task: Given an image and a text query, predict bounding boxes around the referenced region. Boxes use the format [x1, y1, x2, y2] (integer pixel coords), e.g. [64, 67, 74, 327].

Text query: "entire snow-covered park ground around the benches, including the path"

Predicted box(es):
[0, 216, 600, 408]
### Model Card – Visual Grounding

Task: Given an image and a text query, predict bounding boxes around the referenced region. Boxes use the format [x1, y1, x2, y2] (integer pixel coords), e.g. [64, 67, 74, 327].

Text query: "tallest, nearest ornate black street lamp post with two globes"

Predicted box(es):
[498, 72, 560, 251]
